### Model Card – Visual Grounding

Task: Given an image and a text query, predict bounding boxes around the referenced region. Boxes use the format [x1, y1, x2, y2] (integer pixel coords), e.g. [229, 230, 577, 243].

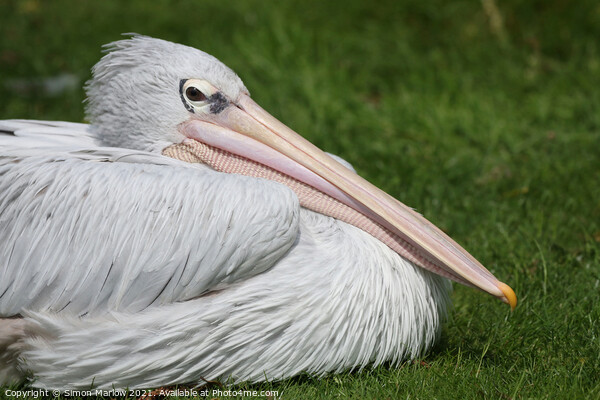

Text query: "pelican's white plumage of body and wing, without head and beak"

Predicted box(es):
[0, 121, 449, 389]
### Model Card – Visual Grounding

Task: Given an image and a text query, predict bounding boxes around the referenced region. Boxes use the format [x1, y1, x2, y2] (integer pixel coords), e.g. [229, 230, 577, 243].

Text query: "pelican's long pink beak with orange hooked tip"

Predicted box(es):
[180, 94, 517, 309]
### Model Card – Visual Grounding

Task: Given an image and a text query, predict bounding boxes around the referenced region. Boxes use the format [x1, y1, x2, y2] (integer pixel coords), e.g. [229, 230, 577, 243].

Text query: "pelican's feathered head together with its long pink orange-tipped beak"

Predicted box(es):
[87, 36, 517, 308]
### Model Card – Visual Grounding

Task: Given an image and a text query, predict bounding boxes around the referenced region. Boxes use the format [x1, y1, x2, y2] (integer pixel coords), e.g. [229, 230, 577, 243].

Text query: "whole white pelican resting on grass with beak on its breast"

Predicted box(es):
[0, 35, 516, 390]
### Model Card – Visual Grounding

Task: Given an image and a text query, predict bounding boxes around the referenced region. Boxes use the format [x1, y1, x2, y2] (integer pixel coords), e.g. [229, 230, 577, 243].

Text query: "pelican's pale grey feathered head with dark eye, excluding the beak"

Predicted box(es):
[86, 35, 249, 152]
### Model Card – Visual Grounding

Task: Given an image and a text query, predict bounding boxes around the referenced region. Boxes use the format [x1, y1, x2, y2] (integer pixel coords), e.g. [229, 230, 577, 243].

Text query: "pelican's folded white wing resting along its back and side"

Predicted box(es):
[0, 121, 299, 316]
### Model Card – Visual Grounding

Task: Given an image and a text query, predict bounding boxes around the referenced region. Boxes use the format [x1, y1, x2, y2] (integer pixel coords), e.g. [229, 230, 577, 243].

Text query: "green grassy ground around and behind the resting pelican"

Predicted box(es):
[0, 0, 600, 399]
